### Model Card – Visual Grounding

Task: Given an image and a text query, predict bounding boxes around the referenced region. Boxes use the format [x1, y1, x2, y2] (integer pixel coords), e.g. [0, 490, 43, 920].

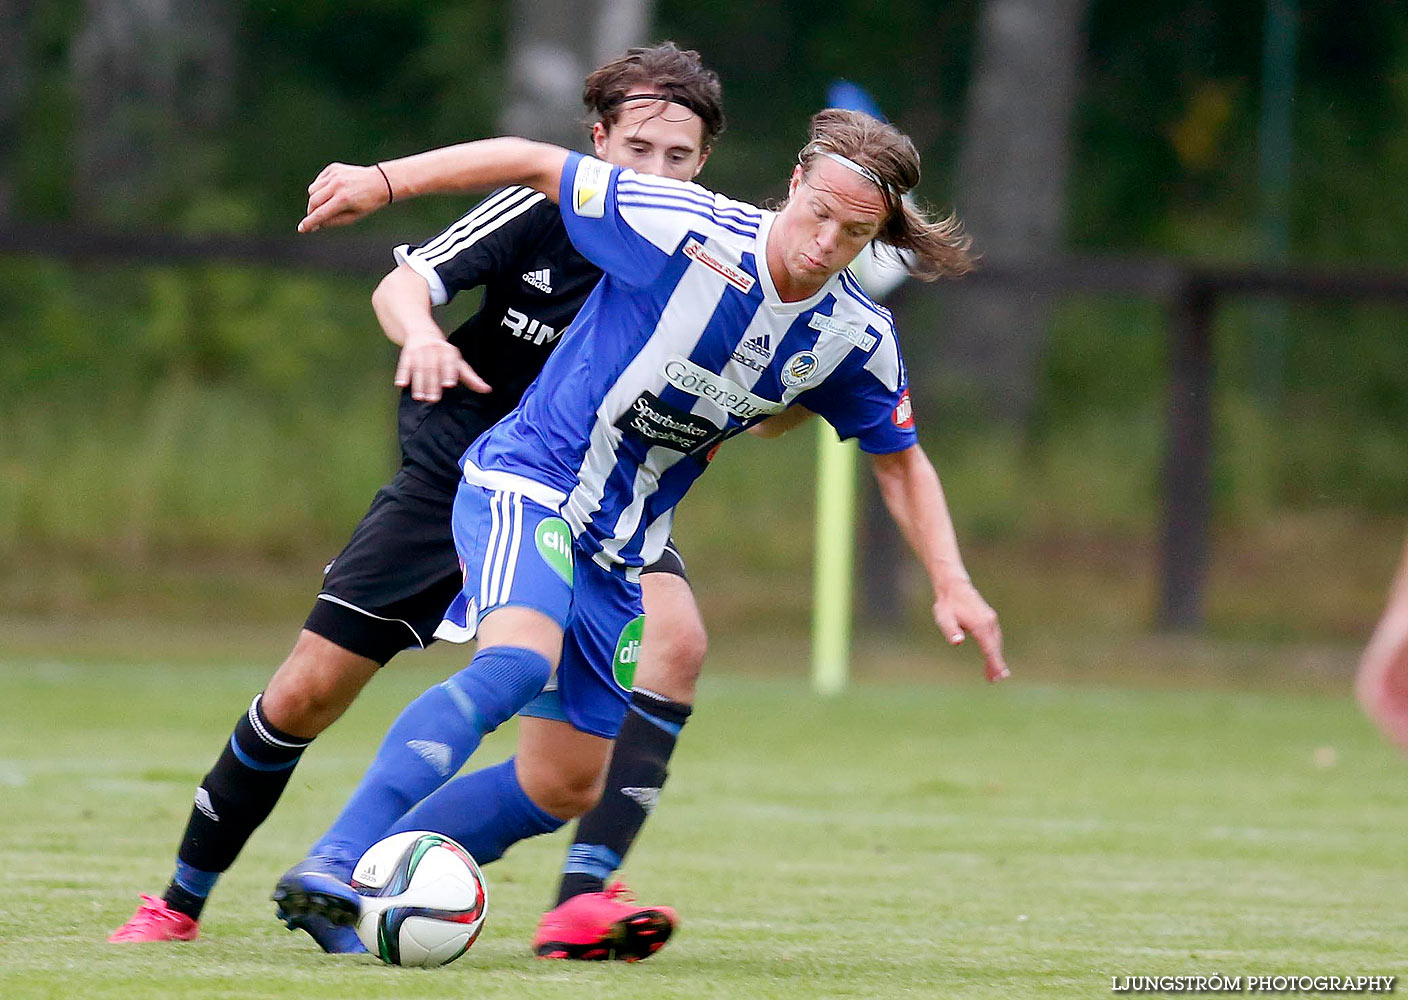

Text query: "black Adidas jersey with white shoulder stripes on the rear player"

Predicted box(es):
[396, 187, 601, 492]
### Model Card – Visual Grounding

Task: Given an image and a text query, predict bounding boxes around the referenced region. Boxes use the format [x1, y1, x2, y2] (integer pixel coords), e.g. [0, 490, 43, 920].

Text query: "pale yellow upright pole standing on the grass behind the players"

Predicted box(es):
[811, 420, 856, 694]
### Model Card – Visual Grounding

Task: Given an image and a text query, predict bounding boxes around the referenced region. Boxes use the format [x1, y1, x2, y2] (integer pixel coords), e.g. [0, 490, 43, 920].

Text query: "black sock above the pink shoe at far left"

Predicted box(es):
[165, 694, 313, 918]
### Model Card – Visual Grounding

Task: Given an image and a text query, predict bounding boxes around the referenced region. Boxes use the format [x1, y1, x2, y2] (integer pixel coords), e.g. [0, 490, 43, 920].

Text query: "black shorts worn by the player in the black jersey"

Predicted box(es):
[303, 470, 689, 663]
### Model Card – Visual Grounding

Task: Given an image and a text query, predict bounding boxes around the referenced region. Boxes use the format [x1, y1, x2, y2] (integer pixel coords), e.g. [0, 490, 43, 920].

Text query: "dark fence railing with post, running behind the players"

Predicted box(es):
[0, 225, 1408, 628]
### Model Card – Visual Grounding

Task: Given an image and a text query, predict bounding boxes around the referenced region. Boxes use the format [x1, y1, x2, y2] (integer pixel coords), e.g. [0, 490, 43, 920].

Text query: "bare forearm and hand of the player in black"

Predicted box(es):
[372, 263, 489, 403]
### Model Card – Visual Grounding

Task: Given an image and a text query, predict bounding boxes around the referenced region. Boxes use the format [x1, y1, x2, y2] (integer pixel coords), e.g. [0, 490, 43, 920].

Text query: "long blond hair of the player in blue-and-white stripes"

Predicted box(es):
[797, 107, 973, 282]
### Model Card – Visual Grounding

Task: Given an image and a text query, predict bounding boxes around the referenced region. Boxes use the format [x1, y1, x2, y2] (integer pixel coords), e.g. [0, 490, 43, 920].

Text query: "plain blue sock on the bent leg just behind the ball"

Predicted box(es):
[389, 758, 566, 865]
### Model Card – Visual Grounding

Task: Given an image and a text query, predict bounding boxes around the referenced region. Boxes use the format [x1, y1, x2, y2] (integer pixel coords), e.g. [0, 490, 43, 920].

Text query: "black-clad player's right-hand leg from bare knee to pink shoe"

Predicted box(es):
[534, 572, 708, 961]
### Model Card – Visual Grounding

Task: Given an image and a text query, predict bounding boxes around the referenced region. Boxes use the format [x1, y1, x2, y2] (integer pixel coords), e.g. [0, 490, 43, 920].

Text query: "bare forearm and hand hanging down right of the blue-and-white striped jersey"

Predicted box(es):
[870, 445, 1008, 690]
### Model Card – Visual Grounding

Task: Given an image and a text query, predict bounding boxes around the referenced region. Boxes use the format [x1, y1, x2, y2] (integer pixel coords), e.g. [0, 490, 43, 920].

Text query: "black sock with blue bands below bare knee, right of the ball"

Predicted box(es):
[558, 687, 690, 906]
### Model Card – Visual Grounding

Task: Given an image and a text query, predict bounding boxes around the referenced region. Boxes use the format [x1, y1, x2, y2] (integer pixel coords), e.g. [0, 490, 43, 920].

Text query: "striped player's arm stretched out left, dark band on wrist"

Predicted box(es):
[298, 135, 567, 232]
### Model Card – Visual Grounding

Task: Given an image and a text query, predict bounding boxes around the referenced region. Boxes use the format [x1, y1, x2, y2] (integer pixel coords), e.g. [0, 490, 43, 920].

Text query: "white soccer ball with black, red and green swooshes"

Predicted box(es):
[352, 830, 489, 968]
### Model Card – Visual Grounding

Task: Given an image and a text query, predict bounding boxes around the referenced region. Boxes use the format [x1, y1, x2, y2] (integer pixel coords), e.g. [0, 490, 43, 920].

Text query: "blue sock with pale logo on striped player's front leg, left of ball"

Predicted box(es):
[310, 646, 552, 873]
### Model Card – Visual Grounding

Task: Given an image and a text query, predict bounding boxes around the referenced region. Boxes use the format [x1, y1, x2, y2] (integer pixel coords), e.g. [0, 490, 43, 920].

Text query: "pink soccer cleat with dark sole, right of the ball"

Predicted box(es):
[532, 882, 679, 962]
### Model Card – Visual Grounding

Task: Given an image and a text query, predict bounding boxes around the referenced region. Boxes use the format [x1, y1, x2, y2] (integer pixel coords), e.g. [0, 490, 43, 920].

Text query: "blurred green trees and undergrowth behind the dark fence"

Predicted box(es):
[0, 0, 1408, 650]
